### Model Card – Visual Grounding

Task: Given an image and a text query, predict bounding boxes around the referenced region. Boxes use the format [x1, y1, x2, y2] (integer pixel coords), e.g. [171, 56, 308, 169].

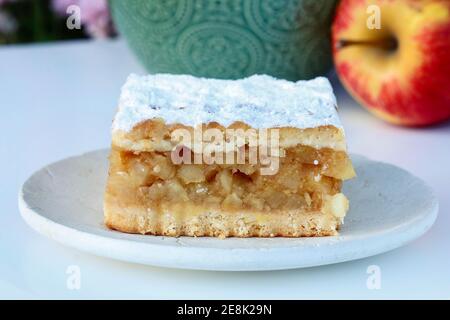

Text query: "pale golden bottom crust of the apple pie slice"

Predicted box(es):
[105, 202, 340, 238]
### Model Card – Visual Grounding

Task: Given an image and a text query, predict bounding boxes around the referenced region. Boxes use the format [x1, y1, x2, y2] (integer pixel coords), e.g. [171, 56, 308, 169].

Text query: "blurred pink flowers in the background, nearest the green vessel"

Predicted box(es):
[51, 0, 114, 38]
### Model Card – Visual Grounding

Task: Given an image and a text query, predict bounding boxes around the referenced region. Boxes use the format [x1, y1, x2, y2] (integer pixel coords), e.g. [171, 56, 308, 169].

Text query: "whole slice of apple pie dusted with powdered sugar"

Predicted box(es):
[104, 74, 355, 237]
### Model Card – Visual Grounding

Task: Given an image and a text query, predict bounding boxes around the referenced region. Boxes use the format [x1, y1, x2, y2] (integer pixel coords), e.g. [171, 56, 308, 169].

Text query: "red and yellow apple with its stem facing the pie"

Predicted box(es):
[332, 0, 450, 126]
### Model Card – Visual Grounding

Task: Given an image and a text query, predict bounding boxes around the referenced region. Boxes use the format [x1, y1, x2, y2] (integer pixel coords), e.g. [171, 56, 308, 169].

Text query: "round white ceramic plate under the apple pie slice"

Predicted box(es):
[19, 150, 438, 270]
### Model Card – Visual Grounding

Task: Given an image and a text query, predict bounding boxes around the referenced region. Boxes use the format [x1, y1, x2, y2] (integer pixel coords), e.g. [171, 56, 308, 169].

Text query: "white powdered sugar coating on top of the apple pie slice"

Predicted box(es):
[113, 74, 342, 135]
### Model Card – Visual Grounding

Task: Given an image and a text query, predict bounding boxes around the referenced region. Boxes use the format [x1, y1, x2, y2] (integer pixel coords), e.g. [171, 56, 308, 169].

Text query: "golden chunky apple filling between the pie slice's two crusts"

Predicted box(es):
[103, 146, 353, 233]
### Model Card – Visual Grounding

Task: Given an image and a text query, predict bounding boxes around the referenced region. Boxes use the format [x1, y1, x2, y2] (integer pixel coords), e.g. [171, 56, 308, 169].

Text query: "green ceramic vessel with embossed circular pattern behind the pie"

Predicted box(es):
[110, 0, 337, 80]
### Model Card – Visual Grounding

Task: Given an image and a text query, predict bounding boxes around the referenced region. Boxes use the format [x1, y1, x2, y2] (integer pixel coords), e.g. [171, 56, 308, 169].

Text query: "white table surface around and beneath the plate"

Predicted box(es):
[0, 40, 450, 299]
